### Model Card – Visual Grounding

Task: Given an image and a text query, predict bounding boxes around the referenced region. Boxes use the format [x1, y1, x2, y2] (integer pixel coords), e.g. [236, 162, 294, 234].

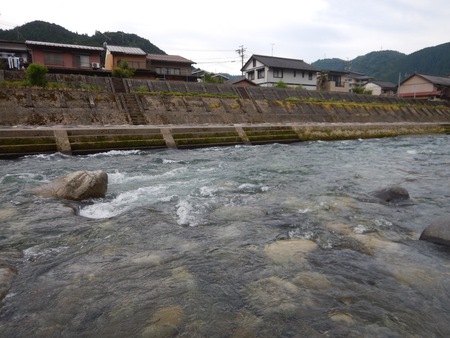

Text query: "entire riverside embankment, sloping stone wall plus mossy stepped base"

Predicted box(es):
[0, 79, 450, 157]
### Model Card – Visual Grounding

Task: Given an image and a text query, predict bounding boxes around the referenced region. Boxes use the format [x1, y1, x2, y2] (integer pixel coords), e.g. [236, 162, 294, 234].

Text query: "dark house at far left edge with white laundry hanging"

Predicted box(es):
[0, 40, 30, 70]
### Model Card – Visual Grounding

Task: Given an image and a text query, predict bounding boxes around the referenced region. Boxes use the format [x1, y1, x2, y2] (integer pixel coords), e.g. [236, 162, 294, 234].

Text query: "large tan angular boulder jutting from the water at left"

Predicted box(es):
[36, 170, 108, 201]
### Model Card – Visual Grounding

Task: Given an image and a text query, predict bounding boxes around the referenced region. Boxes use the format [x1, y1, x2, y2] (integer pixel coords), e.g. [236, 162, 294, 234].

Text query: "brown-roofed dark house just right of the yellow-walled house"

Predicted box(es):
[146, 54, 197, 82]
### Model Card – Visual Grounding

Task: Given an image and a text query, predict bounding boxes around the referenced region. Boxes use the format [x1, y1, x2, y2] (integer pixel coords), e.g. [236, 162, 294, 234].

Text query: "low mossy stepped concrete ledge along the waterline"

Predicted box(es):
[0, 123, 450, 158]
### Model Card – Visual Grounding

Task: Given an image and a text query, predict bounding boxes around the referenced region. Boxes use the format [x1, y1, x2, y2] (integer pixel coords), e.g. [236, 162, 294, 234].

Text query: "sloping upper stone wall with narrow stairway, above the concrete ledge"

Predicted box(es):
[0, 88, 450, 126]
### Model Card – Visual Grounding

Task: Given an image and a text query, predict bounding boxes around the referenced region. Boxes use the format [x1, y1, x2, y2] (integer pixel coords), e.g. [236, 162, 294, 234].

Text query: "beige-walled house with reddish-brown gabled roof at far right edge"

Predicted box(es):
[398, 73, 450, 100]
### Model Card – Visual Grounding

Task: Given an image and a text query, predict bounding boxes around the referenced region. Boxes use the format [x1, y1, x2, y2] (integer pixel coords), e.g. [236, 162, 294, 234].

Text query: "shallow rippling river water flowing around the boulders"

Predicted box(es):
[0, 135, 450, 338]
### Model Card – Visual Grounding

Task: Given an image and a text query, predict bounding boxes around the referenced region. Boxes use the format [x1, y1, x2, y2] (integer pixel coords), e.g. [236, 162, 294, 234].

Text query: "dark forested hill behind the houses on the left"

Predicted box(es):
[0, 21, 166, 54]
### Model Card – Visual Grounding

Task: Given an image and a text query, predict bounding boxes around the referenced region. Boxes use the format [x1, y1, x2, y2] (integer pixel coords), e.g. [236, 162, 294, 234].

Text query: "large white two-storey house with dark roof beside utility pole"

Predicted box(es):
[241, 55, 319, 90]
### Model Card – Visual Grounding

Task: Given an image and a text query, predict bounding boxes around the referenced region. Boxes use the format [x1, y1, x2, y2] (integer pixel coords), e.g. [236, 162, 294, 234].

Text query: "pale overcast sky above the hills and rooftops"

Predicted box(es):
[0, 0, 450, 75]
